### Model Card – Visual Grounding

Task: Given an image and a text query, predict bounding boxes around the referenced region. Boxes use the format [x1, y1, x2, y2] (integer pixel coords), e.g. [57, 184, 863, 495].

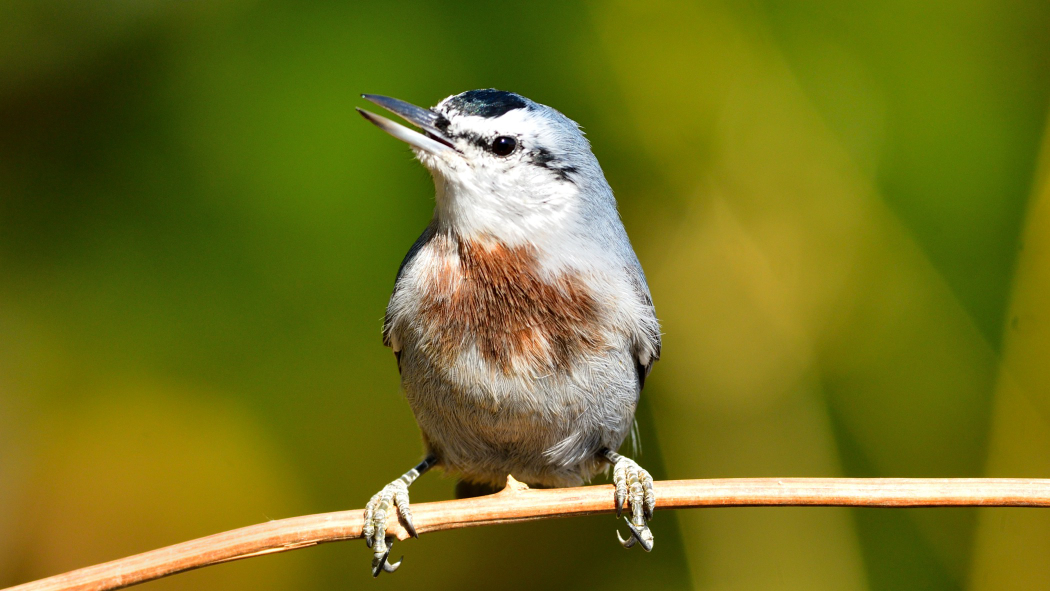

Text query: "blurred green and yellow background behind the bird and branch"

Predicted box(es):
[0, 0, 1050, 590]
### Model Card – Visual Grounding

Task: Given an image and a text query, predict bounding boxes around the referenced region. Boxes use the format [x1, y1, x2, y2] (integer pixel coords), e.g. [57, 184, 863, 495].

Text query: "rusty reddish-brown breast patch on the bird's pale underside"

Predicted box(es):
[420, 237, 602, 373]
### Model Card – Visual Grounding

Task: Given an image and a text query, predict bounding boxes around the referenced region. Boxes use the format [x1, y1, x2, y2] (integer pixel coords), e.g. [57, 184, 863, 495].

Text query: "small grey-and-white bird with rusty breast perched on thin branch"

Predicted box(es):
[357, 89, 660, 576]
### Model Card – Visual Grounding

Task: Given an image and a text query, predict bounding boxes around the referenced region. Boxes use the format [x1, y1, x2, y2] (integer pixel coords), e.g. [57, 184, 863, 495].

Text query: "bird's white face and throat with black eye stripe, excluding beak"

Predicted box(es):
[414, 100, 596, 244]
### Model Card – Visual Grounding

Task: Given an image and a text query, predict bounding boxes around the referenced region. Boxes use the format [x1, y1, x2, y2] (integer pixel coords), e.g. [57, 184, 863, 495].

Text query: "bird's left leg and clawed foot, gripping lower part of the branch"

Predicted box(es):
[361, 453, 438, 576]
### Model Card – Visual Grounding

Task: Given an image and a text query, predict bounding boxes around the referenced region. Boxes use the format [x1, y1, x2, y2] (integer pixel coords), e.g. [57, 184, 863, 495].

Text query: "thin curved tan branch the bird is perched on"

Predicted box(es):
[6, 479, 1050, 591]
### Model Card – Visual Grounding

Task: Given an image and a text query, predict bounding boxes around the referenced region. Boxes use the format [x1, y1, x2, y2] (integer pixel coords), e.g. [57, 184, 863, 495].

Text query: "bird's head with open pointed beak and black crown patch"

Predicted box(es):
[358, 89, 616, 245]
